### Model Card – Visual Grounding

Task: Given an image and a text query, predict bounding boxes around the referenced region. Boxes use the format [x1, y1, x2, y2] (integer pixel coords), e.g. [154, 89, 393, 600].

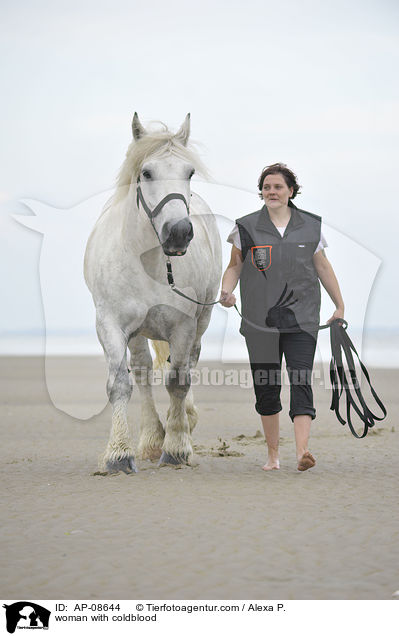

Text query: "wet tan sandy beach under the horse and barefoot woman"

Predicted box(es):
[0, 357, 399, 599]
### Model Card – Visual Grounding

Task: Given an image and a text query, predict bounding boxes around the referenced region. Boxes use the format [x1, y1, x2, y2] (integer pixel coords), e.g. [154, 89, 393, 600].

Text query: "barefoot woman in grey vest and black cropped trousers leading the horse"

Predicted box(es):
[220, 163, 344, 471]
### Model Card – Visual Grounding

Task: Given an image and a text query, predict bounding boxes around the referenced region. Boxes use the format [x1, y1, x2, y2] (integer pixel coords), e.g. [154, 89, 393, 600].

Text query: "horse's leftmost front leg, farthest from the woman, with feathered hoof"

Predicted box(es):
[97, 321, 137, 473]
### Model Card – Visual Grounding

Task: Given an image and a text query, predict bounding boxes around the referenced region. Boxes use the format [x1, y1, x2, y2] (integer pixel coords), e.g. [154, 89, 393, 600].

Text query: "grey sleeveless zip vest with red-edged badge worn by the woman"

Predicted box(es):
[236, 201, 321, 336]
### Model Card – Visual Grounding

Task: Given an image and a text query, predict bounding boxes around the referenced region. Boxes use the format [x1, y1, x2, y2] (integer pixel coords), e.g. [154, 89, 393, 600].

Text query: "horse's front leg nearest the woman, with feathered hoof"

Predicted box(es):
[159, 329, 194, 464]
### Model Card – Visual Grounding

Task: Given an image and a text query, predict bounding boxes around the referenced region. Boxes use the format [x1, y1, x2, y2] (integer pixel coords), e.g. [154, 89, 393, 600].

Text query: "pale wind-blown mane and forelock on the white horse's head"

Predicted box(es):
[106, 122, 209, 208]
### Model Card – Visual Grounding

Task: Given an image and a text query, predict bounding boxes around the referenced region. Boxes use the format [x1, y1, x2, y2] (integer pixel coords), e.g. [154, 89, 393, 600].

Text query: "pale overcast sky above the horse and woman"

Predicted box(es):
[0, 0, 399, 342]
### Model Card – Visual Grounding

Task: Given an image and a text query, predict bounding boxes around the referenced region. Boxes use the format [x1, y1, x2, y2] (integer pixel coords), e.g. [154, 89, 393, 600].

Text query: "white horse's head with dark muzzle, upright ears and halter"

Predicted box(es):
[132, 113, 195, 256]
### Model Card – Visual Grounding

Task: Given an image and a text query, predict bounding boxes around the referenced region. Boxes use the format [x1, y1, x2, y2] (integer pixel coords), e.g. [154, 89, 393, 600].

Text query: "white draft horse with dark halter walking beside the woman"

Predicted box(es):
[84, 113, 221, 472]
